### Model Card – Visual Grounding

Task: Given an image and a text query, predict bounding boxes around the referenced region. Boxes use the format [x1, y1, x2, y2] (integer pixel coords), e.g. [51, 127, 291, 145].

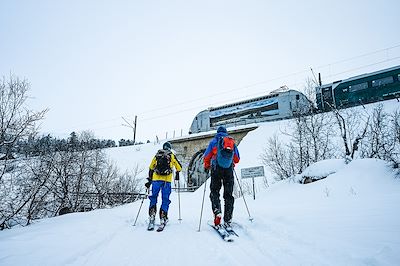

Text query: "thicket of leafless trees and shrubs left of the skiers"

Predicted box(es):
[0, 76, 145, 230]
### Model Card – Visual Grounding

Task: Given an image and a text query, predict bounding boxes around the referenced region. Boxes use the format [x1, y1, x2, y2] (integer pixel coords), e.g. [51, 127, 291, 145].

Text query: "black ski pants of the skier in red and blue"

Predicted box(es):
[210, 166, 235, 222]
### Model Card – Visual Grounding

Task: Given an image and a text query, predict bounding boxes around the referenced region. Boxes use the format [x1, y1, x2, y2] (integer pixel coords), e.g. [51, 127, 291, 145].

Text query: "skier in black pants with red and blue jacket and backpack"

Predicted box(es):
[204, 126, 240, 226]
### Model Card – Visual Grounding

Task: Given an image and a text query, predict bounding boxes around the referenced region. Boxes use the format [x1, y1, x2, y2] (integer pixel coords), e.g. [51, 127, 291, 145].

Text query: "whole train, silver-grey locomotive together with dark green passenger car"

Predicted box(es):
[189, 65, 400, 134]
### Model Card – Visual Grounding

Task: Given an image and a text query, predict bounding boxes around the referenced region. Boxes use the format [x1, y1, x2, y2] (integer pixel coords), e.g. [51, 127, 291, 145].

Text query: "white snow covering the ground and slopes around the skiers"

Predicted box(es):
[0, 100, 400, 265]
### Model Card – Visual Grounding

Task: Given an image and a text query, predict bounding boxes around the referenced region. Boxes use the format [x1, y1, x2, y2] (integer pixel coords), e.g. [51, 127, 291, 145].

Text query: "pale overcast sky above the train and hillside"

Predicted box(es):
[0, 0, 400, 141]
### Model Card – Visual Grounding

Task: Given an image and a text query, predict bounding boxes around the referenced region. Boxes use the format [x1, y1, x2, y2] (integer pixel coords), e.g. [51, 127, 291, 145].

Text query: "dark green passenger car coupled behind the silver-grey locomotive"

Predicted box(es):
[316, 66, 400, 111]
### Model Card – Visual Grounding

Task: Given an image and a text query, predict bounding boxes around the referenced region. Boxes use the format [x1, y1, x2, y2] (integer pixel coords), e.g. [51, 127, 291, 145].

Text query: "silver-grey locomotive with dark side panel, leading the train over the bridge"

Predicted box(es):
[189, 87, 309, 134]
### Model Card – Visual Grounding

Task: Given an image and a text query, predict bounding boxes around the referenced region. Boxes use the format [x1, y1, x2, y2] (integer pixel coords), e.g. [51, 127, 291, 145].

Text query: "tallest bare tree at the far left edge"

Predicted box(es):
[0, 75, 47, 229]
